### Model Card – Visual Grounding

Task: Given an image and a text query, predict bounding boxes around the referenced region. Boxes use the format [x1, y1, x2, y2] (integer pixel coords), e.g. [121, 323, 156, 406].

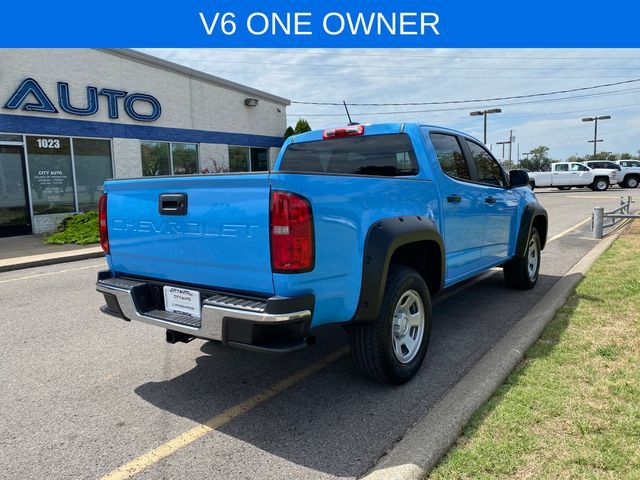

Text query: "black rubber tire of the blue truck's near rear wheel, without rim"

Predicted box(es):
[349, 265, 431, 385]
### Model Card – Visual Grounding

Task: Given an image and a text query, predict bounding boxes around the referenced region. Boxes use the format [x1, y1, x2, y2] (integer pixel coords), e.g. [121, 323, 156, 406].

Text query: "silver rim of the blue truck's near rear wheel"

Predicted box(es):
[391, 290, 425, 363]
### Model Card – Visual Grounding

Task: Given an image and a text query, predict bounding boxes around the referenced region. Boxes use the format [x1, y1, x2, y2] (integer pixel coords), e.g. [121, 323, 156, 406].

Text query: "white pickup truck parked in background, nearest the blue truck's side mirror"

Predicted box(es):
[529, 162, 618, 192]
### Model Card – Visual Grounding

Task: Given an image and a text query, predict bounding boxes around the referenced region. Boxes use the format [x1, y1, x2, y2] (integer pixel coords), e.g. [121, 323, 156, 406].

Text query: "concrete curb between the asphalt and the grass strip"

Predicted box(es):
[363, 233, 619, 480]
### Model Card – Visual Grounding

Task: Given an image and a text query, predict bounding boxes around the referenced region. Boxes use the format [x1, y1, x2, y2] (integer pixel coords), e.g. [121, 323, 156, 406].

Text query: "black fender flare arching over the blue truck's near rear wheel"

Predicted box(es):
[351, 216, 445, 322]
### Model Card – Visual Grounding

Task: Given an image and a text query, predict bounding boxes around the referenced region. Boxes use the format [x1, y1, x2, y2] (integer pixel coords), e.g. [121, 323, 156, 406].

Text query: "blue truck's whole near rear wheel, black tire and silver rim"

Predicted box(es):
[349, 266, 431, 385]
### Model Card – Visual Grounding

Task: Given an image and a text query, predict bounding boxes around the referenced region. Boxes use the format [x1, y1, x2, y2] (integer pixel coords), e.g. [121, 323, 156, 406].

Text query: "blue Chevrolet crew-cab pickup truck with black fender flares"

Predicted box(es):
[97, 123, 547, 384]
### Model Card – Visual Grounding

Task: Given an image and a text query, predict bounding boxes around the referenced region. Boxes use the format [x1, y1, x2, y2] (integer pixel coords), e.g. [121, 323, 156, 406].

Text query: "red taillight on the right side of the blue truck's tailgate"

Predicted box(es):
[269, 191, 314, 273]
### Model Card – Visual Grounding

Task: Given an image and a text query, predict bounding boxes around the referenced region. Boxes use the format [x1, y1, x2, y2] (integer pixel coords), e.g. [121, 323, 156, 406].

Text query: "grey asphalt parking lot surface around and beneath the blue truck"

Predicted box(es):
[0, 187, 640, 479]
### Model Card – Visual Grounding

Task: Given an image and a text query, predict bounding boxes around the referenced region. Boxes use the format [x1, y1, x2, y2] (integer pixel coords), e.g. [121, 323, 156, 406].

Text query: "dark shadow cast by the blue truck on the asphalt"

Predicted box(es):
[136, 272, 560, 479]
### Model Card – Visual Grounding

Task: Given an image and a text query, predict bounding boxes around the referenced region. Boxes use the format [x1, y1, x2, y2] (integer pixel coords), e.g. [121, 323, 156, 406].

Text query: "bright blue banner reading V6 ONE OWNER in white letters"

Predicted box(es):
[0, 0, 640, 48]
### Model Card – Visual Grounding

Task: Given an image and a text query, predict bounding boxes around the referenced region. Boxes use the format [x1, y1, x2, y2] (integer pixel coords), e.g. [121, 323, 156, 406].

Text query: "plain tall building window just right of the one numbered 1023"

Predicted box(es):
[73, 138, 113, 212]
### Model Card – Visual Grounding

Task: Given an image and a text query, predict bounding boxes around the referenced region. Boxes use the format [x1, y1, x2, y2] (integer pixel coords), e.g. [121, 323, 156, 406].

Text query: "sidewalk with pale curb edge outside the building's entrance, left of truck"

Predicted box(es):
[0, 235, 104, 272]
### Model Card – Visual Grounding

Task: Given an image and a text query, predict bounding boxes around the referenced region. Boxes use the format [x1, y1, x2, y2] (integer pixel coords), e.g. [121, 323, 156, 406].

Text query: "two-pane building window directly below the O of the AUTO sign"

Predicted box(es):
[140, 142, 198, 177]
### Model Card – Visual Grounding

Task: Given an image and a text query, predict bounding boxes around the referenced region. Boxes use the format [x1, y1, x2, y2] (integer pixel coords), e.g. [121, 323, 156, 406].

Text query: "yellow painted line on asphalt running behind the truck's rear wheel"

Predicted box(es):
[102, 346, 349, 480]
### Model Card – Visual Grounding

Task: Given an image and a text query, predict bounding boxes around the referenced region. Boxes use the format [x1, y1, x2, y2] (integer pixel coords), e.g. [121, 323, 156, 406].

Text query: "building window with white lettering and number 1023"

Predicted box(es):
[27, 137, 76, 215]
